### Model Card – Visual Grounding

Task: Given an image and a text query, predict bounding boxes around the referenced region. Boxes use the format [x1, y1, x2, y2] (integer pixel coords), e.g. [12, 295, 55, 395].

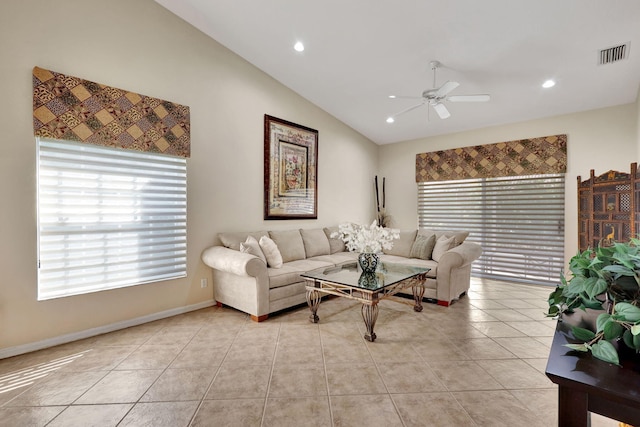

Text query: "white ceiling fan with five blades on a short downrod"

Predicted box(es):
[387, 61, 491, 123]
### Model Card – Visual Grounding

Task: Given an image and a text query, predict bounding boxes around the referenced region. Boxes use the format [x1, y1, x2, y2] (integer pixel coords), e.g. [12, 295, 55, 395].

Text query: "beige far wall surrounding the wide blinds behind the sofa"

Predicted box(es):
[380, 104, 638, 268]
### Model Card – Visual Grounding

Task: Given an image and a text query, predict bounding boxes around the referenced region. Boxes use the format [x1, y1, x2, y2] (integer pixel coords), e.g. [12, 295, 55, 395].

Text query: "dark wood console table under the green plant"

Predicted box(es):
[546, 320, 640, 427]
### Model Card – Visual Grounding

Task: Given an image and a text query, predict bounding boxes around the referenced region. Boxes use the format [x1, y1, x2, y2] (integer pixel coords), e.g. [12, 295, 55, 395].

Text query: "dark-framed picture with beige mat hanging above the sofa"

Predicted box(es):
[264, 114, 318, 219]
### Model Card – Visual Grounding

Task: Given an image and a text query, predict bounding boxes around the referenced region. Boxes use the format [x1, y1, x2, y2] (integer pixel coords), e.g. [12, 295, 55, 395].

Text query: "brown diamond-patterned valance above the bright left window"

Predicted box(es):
[33, 67, 191, 157]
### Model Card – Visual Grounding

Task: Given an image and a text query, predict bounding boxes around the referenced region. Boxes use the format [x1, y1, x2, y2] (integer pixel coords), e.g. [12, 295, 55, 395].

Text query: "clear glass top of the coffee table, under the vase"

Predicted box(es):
[301, 262, 431, 291]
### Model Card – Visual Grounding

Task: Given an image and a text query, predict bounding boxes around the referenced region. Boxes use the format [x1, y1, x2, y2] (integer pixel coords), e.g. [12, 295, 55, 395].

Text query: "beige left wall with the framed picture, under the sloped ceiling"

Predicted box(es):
[0, 0, 378, 354]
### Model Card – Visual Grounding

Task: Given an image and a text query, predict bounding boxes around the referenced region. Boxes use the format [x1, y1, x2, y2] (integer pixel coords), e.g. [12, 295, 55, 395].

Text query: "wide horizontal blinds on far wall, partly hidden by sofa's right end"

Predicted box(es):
[418, 174, 564, 286]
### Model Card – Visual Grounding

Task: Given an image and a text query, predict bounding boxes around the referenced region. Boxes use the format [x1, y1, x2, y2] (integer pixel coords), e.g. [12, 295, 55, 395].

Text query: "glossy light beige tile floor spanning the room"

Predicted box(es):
[0, 279, 618, 427]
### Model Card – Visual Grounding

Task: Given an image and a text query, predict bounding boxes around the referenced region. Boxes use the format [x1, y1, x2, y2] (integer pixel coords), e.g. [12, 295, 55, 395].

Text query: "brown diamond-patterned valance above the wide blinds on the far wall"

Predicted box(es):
[416, 135, 567, 182]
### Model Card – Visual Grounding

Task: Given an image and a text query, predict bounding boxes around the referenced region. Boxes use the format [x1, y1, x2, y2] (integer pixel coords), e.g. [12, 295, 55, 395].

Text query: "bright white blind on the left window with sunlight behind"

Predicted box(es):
[37, 138, 187, 300]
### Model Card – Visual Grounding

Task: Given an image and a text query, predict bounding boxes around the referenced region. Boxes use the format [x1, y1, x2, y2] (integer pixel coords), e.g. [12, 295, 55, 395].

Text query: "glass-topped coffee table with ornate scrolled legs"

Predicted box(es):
[301, 262, 430, 342]
